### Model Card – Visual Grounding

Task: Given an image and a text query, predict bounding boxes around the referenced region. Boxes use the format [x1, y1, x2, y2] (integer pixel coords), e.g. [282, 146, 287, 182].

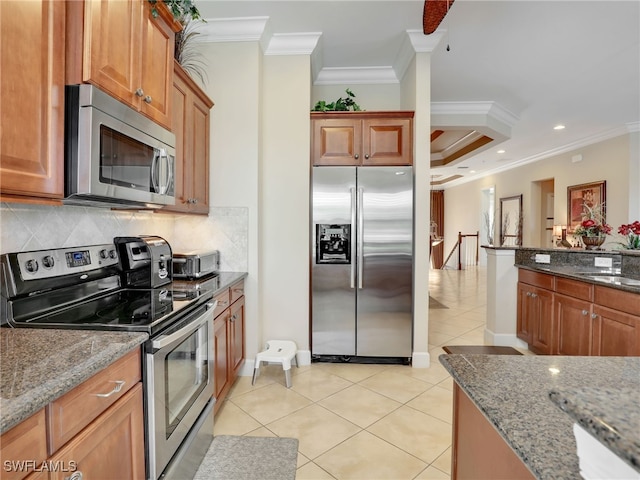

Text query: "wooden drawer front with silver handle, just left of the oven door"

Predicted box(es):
[46, 348, 141, 455]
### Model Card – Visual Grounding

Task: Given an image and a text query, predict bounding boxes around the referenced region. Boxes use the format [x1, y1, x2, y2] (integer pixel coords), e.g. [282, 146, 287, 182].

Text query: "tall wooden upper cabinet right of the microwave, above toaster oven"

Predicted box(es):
[163, 62, 213, 215]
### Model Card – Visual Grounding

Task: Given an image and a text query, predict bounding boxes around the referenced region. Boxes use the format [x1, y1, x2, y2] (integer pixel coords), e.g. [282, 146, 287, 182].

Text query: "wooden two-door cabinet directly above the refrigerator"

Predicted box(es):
[311, 112, 413, 166]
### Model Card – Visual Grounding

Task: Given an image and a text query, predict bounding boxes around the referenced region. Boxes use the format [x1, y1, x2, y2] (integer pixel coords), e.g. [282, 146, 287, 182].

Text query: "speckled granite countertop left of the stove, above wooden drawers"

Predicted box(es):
[0, 328, 148, 434]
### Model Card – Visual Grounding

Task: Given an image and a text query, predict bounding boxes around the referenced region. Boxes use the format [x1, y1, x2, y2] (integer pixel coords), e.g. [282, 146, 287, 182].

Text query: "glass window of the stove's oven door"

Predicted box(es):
[164, 325, 209, 438]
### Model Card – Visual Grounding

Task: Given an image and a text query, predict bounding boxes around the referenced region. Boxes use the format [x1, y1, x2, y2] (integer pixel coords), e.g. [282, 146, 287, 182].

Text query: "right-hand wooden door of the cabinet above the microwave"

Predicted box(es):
[140, 2, 175, 129]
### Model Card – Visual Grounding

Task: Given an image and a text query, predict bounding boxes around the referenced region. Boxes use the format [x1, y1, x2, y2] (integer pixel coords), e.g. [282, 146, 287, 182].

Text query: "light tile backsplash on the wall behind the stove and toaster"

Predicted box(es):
[0, 203, 248, 272]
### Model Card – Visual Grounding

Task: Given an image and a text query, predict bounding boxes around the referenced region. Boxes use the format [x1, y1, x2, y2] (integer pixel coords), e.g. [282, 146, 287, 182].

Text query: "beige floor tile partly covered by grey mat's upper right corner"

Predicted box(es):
[267, 405, 361, 460]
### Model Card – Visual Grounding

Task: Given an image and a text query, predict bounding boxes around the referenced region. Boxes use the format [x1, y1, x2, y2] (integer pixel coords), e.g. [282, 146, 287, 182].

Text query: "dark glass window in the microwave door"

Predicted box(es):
[100, 125, 156, 192]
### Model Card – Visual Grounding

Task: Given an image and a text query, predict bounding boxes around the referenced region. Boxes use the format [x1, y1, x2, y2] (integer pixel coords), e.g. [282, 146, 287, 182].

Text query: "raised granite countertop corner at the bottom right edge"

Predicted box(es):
[549, 386, 640, 472]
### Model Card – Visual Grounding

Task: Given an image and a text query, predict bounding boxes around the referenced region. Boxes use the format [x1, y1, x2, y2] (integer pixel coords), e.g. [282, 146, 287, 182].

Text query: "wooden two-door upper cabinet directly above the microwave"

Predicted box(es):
[65, 0, 181, 128]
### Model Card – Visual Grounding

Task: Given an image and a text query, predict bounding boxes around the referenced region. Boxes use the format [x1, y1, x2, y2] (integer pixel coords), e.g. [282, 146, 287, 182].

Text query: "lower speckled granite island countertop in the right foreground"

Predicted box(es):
[439, 354, 640, 480]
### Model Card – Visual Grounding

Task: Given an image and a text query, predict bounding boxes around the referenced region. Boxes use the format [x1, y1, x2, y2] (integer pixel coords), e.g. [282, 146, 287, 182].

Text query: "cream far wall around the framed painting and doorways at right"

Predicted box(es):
[445, 135, 637, 253]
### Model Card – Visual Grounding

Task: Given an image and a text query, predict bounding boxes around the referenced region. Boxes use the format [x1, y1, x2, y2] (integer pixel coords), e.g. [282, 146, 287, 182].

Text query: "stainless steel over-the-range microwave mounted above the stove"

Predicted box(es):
[64, 84, 176, 208]
